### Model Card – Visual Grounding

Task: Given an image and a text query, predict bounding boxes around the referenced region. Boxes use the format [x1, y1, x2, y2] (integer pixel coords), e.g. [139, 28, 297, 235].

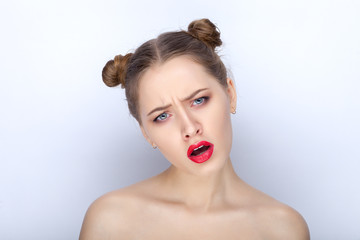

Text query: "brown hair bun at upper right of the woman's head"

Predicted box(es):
[188, 18, 222, 50]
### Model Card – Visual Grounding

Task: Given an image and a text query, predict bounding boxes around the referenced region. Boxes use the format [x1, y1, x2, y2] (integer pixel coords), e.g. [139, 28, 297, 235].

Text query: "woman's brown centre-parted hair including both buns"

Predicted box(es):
[102, 19, 227, 125]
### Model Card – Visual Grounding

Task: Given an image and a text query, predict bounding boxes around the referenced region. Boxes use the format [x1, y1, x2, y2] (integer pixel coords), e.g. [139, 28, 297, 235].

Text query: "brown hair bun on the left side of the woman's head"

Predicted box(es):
[102, 53, 132, 88]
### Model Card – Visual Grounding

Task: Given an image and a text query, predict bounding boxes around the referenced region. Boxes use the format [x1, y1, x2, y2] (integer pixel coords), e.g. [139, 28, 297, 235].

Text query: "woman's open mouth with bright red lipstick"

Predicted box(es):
[187, 141, 214, 163]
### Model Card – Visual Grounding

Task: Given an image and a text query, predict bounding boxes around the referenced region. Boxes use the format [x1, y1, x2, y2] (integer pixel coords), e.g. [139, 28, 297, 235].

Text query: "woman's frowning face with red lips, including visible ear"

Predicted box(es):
[139, 56, 236, 173]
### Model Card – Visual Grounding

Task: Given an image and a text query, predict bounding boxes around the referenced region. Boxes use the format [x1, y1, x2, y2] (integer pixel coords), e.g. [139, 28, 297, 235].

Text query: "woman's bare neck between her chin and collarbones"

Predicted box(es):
[163, 159, 240, 211]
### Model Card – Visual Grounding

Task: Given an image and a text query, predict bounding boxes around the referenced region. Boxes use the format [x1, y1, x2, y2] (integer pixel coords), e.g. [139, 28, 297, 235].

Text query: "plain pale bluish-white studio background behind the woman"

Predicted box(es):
[0, 0, 360, 240]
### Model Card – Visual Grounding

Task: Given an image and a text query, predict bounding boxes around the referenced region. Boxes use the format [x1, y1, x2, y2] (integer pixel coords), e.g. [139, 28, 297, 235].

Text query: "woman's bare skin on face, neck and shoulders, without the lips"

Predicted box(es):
[80, 56, 309, 240]
